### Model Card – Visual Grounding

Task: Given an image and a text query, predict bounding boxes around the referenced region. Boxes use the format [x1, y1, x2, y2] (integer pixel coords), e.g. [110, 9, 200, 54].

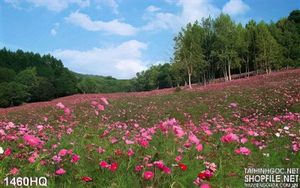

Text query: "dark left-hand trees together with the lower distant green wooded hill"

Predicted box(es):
[0, 48, 132, 107]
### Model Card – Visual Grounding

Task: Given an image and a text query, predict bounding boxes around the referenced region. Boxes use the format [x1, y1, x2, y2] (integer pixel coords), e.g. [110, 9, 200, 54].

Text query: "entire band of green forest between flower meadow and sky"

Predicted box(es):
[0, 10, 300, 107]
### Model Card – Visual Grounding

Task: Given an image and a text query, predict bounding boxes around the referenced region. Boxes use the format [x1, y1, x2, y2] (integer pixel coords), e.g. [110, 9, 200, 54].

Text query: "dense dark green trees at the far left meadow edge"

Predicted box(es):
[0, 48, 78, 107]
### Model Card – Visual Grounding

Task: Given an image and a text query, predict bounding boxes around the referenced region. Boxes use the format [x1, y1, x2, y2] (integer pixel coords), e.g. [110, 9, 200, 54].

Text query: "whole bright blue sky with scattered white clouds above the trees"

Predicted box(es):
[0, 0, 300, 78]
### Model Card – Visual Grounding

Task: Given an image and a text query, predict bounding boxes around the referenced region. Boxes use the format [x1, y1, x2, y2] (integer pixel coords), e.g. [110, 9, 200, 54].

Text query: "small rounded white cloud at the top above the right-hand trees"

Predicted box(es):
[222, 0, 250, 16]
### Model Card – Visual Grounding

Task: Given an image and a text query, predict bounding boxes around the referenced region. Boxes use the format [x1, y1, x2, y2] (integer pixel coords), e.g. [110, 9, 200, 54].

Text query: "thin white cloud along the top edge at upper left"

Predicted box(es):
[5, 0, 90, 12]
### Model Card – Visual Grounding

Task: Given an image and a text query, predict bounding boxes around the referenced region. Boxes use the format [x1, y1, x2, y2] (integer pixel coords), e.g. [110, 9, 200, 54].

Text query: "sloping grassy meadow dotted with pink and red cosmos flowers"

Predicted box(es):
[0, 69, 300, 187]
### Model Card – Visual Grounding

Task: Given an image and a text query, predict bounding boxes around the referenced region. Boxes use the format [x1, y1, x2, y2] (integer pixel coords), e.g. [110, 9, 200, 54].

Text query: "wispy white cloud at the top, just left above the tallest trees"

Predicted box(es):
[143, 0, 220, 31]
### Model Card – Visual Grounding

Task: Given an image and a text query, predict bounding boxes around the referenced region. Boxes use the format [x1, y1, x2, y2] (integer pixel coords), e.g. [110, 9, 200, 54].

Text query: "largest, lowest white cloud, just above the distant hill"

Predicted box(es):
[52, 40, 147, 78]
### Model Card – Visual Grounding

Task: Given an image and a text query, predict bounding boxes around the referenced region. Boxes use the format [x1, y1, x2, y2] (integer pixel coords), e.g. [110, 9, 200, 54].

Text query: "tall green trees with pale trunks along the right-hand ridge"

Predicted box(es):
[133, 10, 300, 90]
